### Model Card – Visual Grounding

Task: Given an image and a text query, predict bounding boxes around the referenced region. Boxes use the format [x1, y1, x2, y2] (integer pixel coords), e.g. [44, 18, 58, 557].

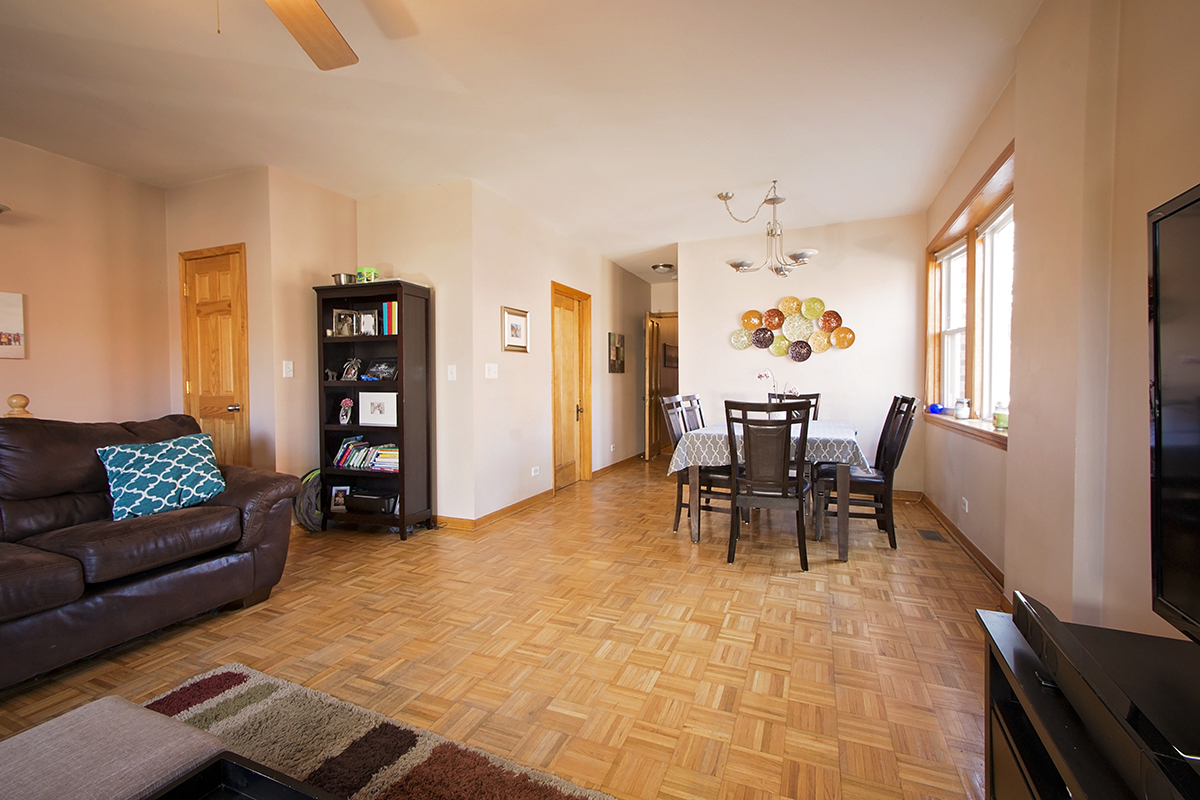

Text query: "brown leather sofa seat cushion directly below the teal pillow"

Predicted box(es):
[22, 506, 241, 583]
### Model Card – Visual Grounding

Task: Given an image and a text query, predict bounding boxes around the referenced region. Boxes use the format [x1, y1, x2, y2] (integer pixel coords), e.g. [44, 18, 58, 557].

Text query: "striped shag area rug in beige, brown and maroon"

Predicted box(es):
[146, 664, 612, 800]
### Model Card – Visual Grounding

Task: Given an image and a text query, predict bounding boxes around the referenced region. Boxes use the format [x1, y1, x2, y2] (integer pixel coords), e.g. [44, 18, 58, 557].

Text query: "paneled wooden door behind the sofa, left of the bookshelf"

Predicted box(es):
[179, 243, 250, 467]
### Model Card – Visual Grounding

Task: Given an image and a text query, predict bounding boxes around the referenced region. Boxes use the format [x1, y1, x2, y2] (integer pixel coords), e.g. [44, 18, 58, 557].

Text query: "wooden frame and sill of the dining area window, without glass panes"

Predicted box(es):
[925, 142, 1015, 449]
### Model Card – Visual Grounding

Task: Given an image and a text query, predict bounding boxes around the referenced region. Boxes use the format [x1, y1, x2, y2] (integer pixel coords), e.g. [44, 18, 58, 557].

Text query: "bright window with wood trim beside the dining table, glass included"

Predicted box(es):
[925, 143, 1015, 420]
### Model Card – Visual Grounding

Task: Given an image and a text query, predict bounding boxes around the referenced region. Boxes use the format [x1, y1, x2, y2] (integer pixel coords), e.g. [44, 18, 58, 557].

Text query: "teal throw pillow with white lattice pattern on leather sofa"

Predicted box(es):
[96, 433, 224, 519]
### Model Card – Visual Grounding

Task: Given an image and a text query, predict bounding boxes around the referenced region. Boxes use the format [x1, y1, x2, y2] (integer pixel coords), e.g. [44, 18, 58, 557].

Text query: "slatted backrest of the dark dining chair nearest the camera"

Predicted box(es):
[725, 401, 812, 497]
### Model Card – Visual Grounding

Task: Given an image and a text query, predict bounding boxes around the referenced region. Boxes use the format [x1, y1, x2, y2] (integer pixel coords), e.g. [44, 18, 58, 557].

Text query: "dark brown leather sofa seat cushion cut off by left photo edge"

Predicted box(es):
[0, 542, 83, 622]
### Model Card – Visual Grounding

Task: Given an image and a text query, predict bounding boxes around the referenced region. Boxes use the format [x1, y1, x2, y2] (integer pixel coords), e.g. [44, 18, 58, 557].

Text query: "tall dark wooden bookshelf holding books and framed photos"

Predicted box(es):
[313, 281, 433, 539]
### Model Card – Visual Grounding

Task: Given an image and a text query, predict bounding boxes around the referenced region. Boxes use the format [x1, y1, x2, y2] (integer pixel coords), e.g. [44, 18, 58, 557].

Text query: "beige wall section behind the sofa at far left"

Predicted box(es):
[0, 139, 172, 421]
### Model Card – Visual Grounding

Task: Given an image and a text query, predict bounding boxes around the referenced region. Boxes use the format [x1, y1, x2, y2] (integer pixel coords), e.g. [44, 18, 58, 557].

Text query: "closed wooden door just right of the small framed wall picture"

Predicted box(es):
[551, 283, 592, 489]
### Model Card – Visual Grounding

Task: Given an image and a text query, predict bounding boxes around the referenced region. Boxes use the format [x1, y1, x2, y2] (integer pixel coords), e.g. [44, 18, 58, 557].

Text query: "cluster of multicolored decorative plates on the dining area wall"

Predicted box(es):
[730, 296, 854, 363]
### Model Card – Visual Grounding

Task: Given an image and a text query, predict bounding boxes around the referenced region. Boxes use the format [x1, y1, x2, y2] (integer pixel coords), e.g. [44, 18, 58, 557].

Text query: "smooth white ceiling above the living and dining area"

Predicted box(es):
[0, 0, 1040, 279]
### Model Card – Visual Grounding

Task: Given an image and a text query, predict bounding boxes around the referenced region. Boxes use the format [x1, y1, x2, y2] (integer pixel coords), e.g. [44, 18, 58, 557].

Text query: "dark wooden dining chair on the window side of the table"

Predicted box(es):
[812, 396, 917, 549]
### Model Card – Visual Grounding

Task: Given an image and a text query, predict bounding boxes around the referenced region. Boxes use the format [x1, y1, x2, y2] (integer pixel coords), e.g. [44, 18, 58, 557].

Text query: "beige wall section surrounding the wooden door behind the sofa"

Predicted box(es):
[163, 167, 275, 469]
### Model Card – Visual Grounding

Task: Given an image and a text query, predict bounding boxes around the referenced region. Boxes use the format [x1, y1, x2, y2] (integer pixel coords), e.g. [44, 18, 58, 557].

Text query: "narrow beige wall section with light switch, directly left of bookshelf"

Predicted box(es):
[268, 167, 358, 475]
